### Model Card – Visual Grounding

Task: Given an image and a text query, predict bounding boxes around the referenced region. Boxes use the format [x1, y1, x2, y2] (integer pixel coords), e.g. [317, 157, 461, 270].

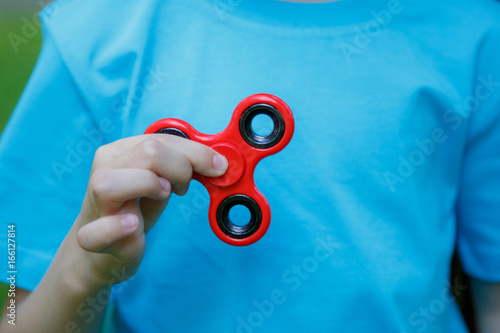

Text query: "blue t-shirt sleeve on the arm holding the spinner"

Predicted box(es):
[0, 24, 102, 290]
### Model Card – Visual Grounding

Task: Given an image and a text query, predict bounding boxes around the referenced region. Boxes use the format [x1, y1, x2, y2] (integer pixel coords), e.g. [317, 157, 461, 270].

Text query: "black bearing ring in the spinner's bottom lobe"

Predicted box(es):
[217, 194, 262, 239]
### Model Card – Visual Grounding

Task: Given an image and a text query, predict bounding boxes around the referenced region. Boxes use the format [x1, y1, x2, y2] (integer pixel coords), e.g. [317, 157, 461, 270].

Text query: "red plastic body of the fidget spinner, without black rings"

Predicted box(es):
[145, 94, 294, 246]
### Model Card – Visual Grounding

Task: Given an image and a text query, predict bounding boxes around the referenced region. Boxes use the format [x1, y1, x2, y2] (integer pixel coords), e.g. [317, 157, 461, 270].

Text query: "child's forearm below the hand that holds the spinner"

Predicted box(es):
[0, 224, 112, 333]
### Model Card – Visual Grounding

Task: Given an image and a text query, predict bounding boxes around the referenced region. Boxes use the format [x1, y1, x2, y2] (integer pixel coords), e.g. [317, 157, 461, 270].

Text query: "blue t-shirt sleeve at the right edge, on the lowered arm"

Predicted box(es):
[457, 27, 500, 282]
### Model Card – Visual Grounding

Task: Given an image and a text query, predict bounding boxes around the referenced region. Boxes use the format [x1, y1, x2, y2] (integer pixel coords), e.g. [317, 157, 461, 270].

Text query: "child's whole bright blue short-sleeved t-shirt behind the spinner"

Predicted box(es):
[0, 0, 500, 333]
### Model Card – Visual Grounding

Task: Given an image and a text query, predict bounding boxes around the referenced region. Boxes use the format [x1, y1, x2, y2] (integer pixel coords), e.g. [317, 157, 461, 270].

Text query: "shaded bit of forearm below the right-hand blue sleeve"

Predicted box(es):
[471, 279, 500, 333]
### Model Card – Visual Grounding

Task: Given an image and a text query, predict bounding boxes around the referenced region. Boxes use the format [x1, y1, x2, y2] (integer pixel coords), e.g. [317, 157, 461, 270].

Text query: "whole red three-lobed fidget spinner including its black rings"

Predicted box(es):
[144, 94, 294, 246]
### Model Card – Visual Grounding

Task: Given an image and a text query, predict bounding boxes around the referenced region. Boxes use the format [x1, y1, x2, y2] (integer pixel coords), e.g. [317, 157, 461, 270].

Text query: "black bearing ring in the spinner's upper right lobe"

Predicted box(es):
[240, 103, 285, 148]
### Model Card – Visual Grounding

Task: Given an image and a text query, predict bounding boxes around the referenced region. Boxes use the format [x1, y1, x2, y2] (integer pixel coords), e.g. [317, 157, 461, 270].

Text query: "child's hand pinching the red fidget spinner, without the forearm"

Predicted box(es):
[74, 134, 227, 287]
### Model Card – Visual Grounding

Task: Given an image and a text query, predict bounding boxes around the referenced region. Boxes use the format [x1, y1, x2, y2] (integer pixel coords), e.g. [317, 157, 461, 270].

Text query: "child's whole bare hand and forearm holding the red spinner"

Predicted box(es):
[0, 134, 228, 333]
